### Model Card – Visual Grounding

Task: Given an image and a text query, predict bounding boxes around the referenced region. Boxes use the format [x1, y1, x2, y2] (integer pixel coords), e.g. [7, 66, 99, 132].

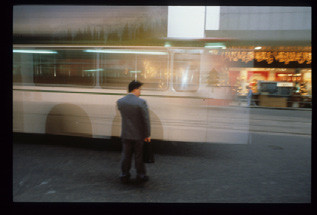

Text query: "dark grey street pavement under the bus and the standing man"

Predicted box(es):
[13, 129, 311, 203]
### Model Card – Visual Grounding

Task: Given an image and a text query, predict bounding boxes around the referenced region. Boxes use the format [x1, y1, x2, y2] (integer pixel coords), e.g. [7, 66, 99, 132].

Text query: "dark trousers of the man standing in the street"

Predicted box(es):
[121, 139, 146, 177]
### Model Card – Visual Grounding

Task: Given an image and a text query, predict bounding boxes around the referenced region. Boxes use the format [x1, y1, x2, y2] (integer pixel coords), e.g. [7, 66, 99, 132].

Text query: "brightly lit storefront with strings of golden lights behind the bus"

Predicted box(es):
[218, 47, 312, 107]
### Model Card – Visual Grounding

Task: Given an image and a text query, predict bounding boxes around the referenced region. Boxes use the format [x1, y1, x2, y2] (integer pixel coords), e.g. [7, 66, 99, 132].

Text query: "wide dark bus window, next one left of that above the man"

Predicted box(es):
[34, 50, 97, 86]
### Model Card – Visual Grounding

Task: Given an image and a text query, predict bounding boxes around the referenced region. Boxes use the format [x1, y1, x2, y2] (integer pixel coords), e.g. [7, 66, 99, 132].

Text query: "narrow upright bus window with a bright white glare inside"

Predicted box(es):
[173, 54, 200, 92]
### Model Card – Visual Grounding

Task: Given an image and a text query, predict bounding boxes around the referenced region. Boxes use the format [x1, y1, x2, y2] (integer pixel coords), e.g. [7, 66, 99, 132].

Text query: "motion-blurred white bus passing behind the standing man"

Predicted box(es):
[13, 45, 249, 144]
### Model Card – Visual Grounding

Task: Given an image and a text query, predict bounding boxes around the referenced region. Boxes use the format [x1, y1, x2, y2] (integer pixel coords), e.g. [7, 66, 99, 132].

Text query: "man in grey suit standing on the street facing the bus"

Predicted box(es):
[117, 81, 151, 183]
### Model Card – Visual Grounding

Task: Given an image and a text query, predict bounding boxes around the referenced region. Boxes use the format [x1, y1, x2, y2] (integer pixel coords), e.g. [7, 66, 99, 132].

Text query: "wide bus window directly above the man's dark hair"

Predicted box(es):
[100, 51, 168, 90]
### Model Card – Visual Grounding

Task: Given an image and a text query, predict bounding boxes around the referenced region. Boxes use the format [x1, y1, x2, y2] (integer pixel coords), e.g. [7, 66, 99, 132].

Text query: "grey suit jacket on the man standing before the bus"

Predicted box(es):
[117, 93, 151, 140]
